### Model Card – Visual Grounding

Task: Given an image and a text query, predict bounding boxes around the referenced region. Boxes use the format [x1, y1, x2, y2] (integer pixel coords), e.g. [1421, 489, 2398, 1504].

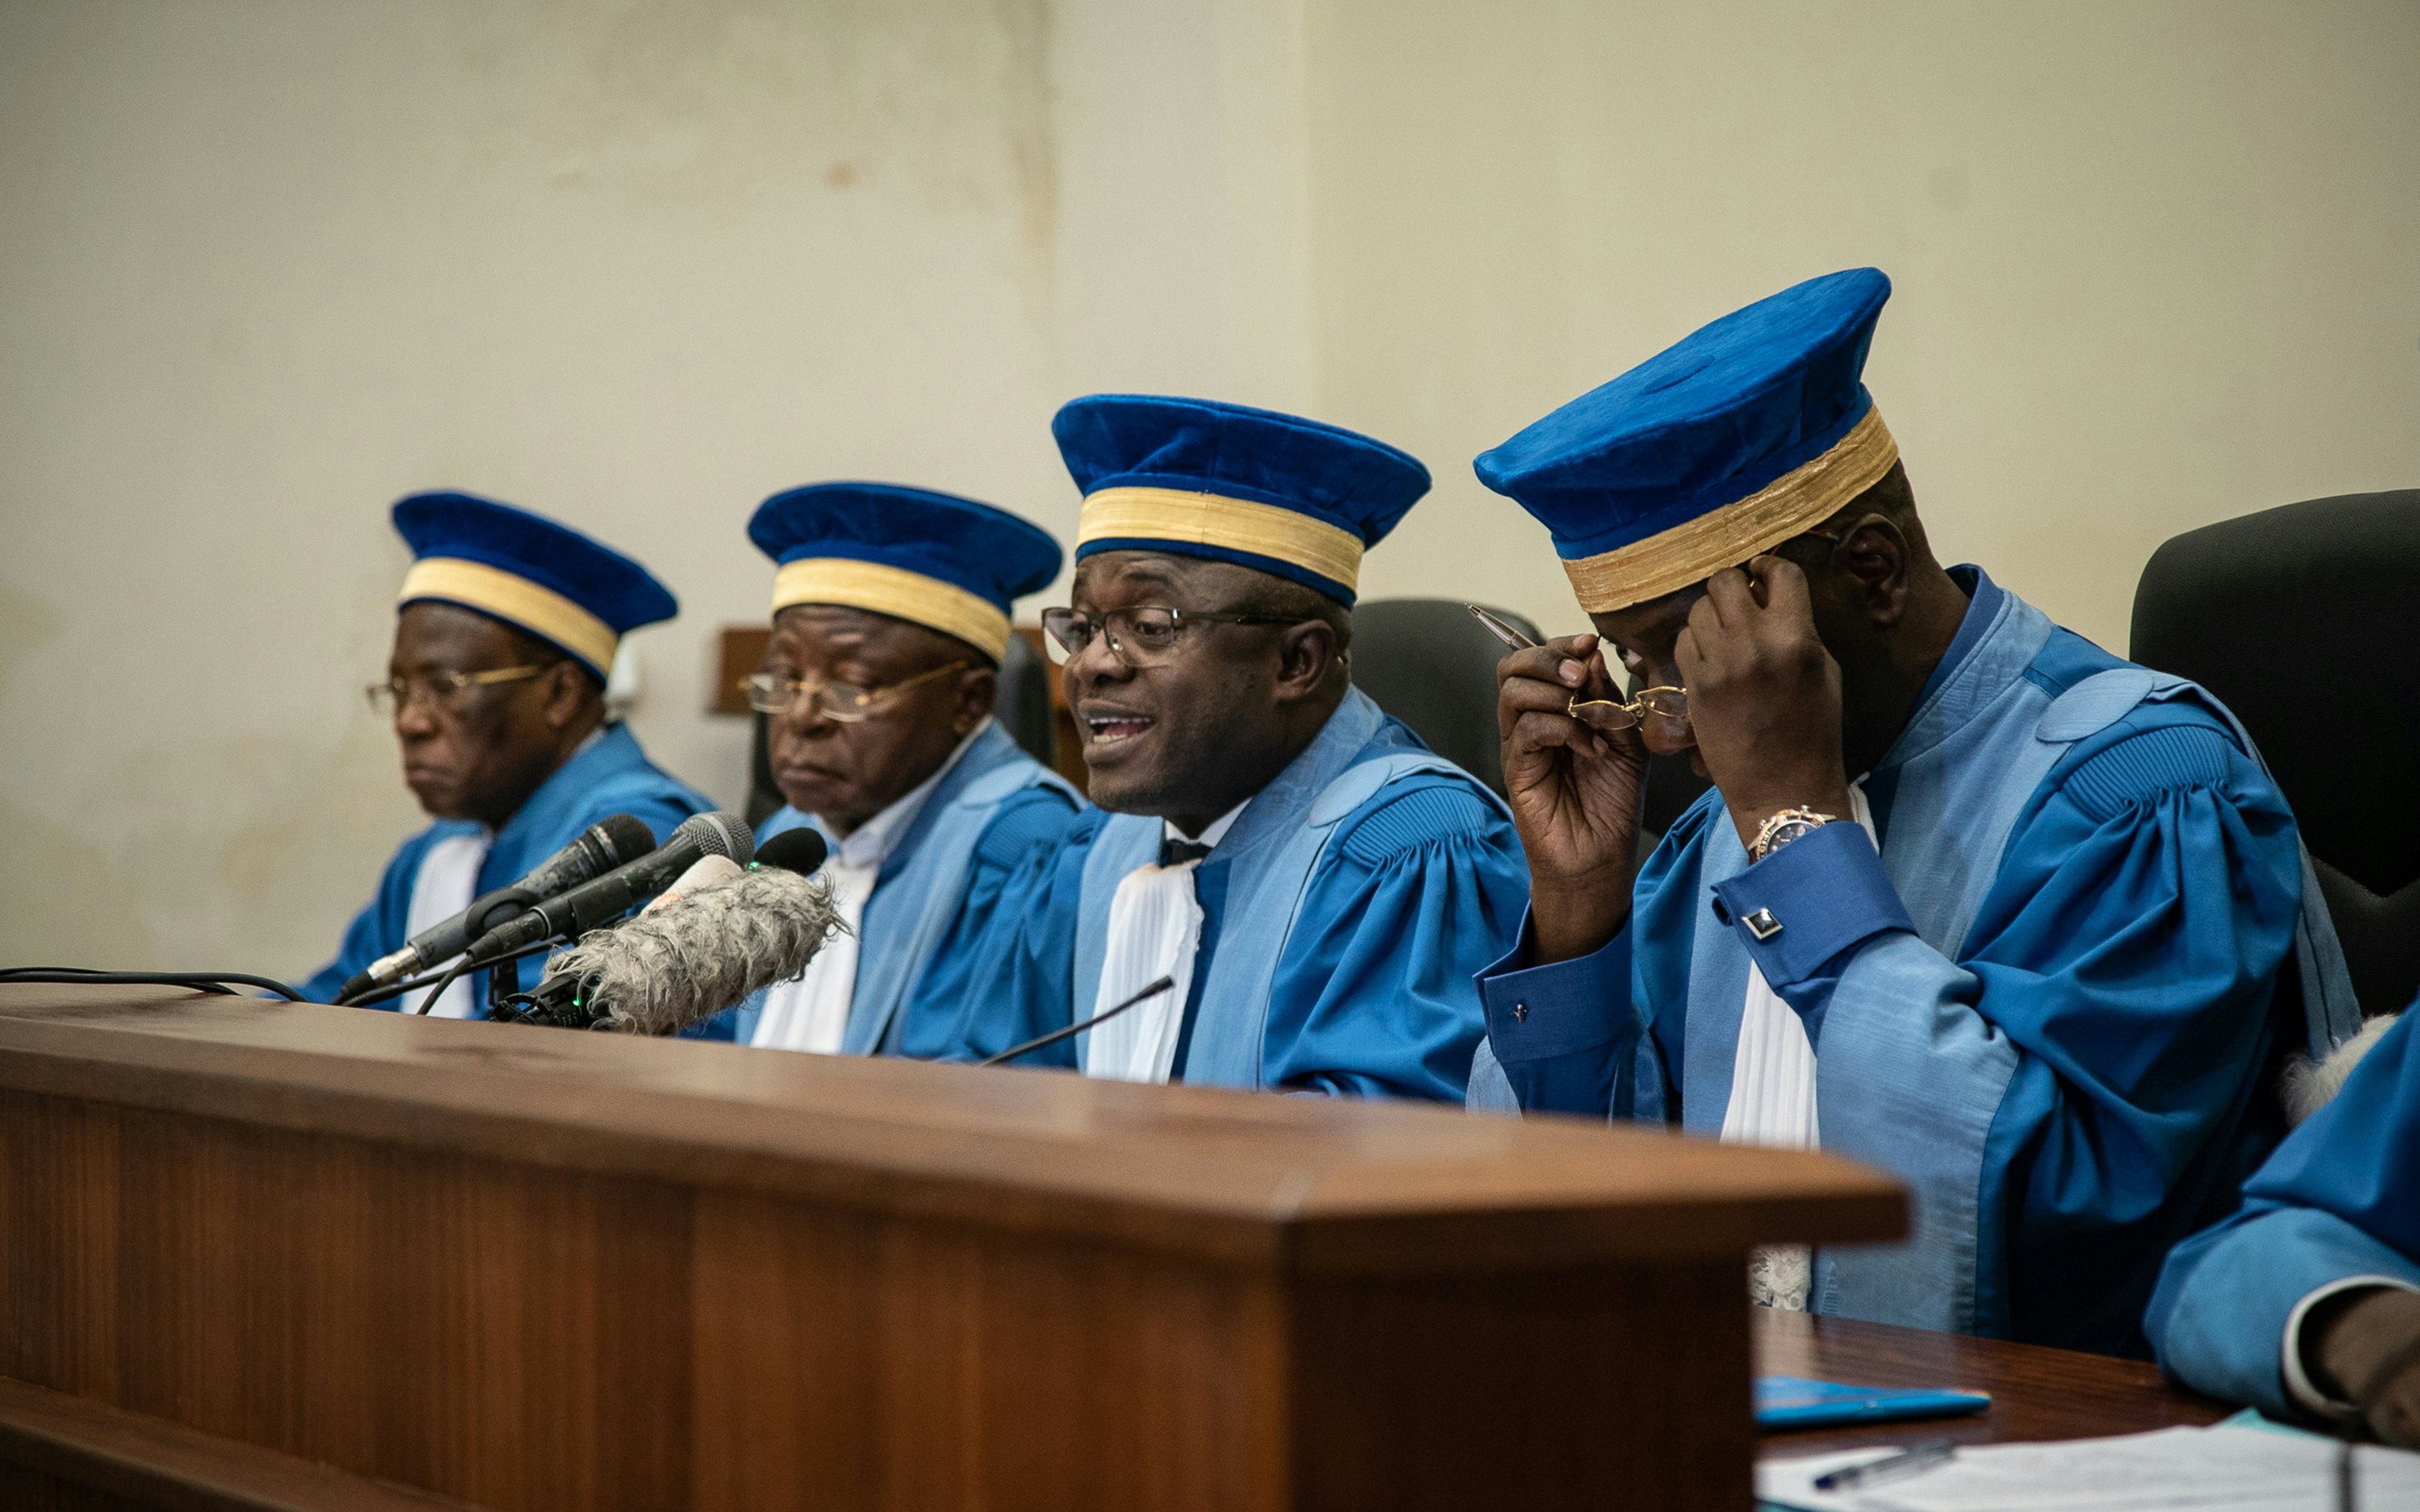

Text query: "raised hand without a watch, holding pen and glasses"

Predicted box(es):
[1496, 636, 1648, 965]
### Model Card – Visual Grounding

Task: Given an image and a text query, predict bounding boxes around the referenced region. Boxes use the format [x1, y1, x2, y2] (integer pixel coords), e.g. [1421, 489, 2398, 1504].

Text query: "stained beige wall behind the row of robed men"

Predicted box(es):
[0, 0, 2420, 973]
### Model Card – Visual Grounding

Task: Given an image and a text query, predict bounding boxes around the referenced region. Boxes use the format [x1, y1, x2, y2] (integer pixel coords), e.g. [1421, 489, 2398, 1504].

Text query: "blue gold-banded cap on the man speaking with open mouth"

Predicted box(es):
[1050, 394, 1428, 605]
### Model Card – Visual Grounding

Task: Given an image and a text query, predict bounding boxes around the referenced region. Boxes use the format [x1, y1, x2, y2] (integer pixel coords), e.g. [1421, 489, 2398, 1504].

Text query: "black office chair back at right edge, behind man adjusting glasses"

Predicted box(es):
[2132, 489, 2420, 1014]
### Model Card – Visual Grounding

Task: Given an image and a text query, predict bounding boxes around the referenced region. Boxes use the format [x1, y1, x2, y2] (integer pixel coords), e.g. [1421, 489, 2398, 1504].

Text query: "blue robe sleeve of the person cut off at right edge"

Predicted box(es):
[2144, 1009, 2420, 1418]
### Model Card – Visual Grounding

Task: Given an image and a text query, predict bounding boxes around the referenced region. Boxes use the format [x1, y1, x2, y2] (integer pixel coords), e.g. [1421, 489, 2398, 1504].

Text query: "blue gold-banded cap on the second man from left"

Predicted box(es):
[748, 484, 1062, 660]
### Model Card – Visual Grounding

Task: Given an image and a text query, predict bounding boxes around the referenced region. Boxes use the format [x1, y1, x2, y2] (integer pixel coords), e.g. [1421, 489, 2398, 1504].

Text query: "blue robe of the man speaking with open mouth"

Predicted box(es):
[927, 689, 1529, 1098]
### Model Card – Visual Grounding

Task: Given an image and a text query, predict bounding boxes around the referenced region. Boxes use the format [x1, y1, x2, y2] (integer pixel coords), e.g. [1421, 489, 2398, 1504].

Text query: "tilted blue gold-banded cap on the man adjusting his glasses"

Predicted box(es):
[1474, 269, 1897, 610]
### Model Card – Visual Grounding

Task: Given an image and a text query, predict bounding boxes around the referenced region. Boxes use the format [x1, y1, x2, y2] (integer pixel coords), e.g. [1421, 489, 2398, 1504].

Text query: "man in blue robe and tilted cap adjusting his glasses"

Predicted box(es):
[1471, 269, 2352, 1355]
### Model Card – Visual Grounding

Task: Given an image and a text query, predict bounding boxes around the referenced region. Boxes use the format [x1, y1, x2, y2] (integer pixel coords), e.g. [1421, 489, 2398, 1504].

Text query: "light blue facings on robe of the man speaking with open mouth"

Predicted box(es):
[1072, 687, 1510, 1089]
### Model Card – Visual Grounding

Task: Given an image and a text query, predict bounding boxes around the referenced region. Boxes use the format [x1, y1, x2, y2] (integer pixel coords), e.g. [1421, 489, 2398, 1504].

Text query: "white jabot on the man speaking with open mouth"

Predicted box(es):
[1084, 798, 1249, 1081]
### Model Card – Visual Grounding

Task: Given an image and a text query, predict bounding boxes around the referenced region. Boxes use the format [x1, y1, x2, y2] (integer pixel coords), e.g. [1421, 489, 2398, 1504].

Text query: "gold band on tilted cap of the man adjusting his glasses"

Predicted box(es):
[1563, 406, 1900, 614]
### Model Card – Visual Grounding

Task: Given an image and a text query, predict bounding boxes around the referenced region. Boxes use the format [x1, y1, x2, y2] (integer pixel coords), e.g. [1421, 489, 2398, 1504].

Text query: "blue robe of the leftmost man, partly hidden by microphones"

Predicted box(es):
[300, 723, 714, 1018]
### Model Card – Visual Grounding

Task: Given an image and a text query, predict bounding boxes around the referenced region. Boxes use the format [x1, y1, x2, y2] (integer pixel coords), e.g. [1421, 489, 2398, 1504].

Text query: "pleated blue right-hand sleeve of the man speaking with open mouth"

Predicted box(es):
[1258, 779, 1529, 1101]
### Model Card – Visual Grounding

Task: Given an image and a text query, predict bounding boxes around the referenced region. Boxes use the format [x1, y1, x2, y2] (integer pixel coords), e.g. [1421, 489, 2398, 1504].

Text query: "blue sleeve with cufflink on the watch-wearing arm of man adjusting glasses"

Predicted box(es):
[1716, 704, 2301, 1355]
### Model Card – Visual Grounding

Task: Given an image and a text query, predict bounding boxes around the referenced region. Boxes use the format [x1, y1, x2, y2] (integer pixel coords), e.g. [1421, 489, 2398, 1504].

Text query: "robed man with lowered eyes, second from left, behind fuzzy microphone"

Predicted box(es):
[699, 484, 1082, 1060]
